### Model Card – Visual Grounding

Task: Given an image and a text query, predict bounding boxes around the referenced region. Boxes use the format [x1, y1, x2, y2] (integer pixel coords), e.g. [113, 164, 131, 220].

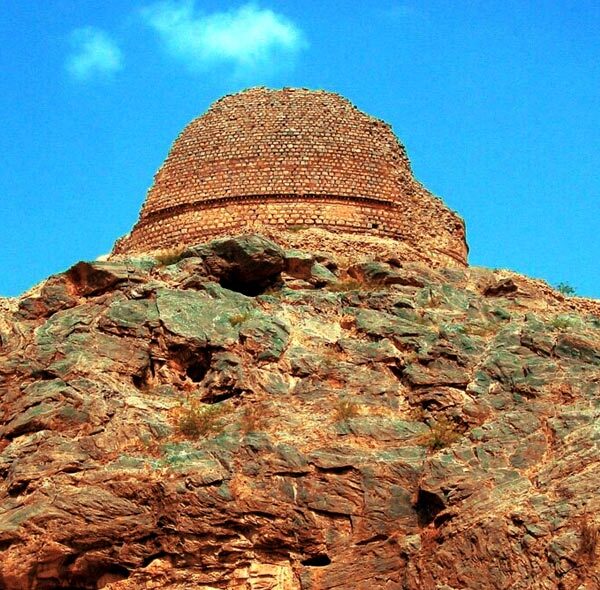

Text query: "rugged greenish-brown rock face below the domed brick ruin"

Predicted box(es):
[0, 236, 600, 590]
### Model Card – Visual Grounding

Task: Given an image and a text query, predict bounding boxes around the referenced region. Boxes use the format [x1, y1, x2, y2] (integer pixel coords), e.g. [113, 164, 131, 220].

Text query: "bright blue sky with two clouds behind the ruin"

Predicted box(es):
[0, 0, 600, 297]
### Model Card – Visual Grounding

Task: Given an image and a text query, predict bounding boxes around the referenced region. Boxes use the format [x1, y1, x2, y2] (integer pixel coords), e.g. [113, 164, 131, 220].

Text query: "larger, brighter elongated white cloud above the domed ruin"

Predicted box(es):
[142, 0, 306, 75]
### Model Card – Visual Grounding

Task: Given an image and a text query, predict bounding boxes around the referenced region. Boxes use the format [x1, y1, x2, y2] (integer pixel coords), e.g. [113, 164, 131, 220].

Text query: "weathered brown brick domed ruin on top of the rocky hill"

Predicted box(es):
[114, 88, 467, 263]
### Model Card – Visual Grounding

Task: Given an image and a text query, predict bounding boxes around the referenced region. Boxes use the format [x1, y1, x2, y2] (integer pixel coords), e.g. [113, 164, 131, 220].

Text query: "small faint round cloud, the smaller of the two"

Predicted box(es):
[65, 27, 123, 81]
